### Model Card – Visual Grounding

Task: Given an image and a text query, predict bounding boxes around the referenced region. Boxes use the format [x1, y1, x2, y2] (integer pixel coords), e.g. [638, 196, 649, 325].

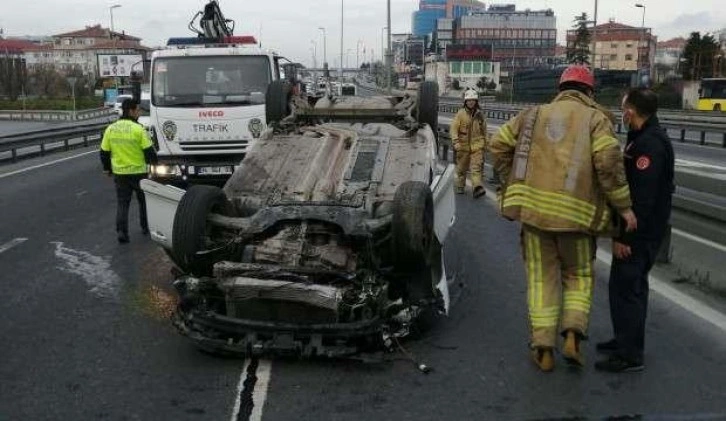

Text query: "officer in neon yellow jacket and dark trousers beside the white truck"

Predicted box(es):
[101, 99, 156, 244]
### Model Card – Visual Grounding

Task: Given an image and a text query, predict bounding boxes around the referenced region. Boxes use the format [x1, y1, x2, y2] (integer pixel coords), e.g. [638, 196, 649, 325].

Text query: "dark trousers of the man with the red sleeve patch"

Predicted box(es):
[609, 241, 660, 362]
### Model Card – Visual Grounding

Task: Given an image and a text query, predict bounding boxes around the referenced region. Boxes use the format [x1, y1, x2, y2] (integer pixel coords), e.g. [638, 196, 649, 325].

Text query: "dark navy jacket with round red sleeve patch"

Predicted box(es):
[618, 116, 675, 244]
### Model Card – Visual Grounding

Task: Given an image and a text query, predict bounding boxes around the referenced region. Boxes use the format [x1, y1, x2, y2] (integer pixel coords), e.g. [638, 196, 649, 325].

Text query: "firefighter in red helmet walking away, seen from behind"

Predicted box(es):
[490, 66, 637, 371]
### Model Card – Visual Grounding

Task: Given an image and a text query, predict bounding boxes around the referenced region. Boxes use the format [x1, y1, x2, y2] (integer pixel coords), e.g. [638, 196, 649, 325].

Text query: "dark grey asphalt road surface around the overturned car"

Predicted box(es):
[0, 151, 726, 421]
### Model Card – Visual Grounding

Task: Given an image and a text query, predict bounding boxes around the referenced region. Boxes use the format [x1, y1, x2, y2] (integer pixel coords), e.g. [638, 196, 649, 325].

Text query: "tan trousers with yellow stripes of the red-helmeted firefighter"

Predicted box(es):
[521, 225, 596, 348]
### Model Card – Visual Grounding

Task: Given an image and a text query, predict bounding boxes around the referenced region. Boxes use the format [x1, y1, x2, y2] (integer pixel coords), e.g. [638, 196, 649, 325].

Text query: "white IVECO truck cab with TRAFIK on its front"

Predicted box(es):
[149, 36, 281, 186]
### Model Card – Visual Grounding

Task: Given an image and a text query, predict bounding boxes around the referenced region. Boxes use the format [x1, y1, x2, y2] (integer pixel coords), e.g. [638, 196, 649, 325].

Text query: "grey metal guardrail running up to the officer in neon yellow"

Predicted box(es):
[0, 123, 108, 162]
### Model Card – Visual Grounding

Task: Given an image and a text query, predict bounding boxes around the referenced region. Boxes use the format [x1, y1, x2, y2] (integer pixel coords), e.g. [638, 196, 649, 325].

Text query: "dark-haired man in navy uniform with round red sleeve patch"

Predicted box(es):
[595, 88, 675, 372]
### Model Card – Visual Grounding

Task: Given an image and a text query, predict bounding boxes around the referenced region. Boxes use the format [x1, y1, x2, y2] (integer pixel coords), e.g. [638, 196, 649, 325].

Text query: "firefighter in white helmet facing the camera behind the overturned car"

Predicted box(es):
[450, 89, 487, 198]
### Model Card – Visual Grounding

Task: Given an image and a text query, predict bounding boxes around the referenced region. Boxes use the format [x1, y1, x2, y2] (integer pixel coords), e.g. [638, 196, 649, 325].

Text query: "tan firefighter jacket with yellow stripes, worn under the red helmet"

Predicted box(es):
[489, 91, 631, 235]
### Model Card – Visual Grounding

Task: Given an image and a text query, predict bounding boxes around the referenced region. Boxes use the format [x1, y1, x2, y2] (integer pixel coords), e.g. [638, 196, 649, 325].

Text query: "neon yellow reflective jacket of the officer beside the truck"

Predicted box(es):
[101, 119, 152, 175]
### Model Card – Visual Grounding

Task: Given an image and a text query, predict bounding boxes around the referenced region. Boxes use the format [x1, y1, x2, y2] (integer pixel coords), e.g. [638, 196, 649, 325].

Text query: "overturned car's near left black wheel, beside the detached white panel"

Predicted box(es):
[172, 185, 231, 276]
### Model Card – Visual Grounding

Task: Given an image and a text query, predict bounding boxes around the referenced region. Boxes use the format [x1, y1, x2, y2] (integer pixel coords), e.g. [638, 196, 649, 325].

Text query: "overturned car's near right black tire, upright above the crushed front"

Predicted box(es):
[391, 181, 434, 271]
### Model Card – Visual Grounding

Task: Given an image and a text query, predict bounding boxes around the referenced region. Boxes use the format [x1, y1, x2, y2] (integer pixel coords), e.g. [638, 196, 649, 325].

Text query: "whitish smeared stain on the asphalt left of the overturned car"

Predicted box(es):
[51, 242, 122, 298]
